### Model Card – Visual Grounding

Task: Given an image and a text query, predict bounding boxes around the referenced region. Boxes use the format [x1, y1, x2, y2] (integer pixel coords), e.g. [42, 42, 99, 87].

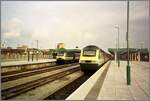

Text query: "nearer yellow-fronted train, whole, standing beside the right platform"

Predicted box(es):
[79, 45, 111, 72]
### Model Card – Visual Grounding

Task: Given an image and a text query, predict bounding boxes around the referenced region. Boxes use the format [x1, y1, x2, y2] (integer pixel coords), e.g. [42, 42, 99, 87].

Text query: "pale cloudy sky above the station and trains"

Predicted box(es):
[1, 1, 149, 50]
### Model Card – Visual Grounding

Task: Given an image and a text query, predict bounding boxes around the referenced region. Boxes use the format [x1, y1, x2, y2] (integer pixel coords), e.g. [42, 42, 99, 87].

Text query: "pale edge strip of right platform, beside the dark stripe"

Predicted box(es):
[66, 62, 110, 100]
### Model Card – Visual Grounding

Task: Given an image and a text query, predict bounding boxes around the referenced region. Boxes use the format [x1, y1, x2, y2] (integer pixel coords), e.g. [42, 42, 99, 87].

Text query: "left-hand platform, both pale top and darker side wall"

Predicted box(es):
[1, 59, 56, 73]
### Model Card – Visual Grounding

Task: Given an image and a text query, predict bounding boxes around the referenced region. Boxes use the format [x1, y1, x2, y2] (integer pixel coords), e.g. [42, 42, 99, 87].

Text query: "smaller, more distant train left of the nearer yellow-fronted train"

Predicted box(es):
[56, 49, 81, 64]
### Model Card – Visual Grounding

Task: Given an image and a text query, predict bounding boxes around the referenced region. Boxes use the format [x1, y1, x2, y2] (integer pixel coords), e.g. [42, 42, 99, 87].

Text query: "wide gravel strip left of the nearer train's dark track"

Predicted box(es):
[12, 71, 83, 100]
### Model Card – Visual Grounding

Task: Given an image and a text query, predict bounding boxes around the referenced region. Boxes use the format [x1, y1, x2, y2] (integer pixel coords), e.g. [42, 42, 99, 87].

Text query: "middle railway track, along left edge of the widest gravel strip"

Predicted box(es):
[1, 65, 80, 100]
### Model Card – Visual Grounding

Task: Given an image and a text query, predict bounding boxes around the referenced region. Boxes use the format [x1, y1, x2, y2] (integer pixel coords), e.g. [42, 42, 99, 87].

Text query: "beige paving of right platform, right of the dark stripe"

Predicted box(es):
[97, 61, 150, 100]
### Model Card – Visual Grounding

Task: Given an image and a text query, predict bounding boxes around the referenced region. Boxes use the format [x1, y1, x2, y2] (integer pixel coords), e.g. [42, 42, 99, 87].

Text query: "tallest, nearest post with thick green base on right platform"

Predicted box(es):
[126, 0, 131, 85]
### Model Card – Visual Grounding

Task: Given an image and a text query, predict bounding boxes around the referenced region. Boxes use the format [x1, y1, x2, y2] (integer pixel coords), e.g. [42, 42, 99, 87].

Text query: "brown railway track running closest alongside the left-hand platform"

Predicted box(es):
[1, 63, 77, 82]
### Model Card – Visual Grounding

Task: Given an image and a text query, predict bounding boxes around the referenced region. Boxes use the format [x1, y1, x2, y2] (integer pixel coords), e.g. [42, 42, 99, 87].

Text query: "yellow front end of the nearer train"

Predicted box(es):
[79, 46, 104, 71]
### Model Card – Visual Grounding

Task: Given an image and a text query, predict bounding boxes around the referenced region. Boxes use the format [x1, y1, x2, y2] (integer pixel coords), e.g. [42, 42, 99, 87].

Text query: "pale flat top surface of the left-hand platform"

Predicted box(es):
[1, 59, 56, 66]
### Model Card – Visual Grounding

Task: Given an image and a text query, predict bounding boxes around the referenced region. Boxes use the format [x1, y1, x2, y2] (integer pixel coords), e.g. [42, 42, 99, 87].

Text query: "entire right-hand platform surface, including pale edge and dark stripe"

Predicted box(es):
[66, 61, 150, 100]
